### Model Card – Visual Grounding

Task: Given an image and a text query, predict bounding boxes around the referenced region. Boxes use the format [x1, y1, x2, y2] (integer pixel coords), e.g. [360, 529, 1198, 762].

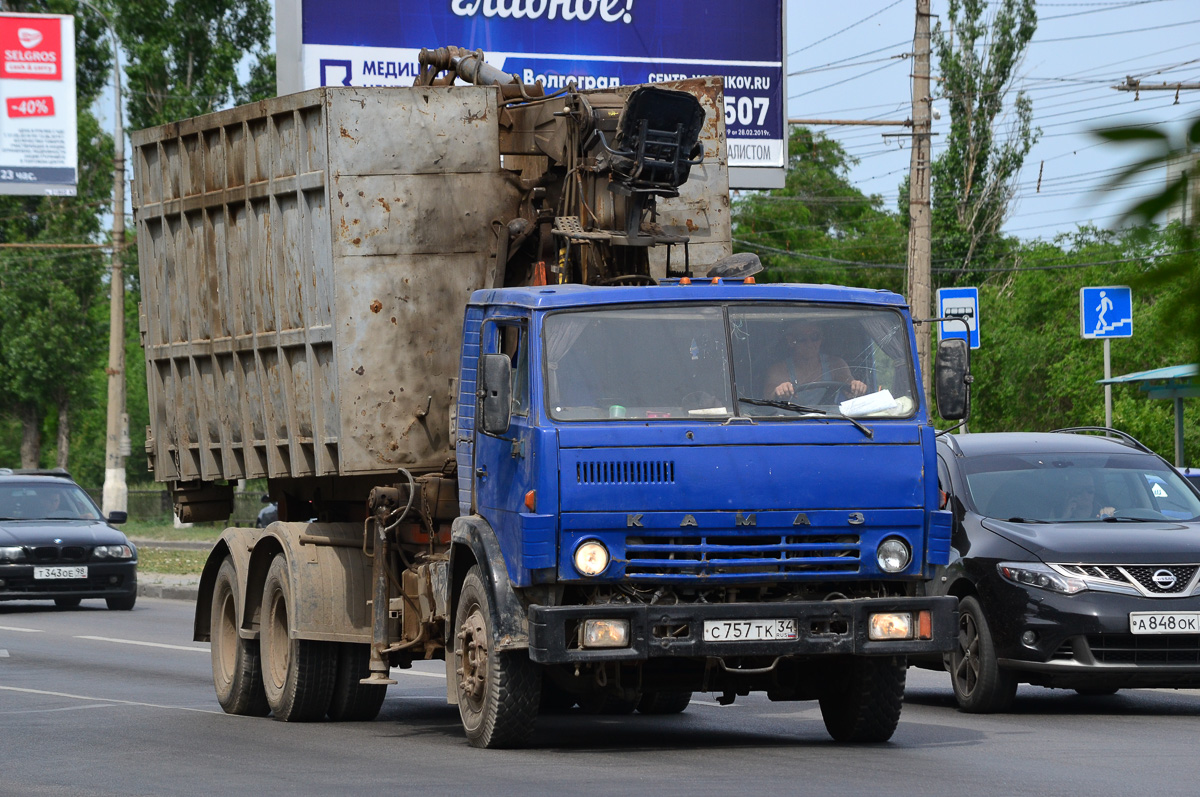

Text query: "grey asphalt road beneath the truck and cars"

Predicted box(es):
[0, 598, 1200, 797]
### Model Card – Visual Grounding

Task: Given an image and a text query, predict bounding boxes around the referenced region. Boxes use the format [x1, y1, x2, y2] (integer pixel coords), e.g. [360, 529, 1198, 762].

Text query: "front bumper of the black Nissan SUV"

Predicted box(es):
[985, 585, 1200, 688]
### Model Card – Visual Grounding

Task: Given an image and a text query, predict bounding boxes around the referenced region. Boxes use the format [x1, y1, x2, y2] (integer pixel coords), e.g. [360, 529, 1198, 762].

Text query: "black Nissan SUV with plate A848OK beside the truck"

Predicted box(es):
[917, 427, 1200, 712]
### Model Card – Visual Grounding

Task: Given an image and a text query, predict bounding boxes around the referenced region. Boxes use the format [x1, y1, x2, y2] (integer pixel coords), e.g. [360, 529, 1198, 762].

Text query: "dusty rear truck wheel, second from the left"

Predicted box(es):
[259, 553, 337, 723]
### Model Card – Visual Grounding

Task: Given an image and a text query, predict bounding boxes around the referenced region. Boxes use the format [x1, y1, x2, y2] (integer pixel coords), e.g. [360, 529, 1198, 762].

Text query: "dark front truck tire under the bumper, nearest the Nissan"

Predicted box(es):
[821, 657, 907, 743]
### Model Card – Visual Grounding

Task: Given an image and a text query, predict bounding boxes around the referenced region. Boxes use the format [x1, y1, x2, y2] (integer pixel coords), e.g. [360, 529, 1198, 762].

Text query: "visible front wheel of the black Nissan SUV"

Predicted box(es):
[950, 595, 1016, 714]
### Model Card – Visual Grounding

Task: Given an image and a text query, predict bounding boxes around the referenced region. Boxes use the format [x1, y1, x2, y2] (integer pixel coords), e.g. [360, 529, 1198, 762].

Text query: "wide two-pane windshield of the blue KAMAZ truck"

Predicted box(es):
[544, 305, 916, 420]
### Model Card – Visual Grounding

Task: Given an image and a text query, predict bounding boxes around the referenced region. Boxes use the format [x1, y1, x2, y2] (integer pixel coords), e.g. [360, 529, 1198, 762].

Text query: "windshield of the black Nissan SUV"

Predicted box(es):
[965, 453, 1200, 522]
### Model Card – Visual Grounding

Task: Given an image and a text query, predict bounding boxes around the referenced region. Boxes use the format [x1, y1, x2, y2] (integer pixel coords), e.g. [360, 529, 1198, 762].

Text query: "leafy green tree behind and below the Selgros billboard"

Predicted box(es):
[0, 0, 113, 467]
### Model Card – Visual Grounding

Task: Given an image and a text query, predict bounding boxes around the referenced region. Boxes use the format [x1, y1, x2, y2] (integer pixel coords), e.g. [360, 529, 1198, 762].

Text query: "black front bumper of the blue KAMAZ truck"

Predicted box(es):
[529, 598, 958, 664]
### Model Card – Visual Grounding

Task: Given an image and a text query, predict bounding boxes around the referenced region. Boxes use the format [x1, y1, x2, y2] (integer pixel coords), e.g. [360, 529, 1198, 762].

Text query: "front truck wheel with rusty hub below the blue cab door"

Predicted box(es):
[454, 565, 541, 749]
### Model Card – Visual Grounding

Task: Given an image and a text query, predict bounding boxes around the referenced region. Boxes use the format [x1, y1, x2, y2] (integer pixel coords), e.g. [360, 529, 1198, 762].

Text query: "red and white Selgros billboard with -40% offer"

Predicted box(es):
[0, 13, 78, 197]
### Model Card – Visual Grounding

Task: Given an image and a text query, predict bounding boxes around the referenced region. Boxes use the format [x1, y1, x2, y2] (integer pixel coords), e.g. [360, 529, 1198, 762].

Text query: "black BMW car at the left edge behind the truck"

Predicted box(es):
[0, 468, 138, 610]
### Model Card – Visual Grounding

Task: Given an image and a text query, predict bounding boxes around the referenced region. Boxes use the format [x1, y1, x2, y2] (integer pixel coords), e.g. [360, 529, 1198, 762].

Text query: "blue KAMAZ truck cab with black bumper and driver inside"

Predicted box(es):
[448, 278, 954, 738]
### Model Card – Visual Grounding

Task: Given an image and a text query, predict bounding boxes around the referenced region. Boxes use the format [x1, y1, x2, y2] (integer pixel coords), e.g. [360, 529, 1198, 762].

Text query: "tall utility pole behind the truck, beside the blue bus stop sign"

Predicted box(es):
[907, 0, 934, 397]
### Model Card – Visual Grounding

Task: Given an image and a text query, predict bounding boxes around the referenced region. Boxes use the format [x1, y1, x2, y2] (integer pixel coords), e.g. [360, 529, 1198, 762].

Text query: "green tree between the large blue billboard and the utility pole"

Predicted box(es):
[733, 127, 907, 290]
